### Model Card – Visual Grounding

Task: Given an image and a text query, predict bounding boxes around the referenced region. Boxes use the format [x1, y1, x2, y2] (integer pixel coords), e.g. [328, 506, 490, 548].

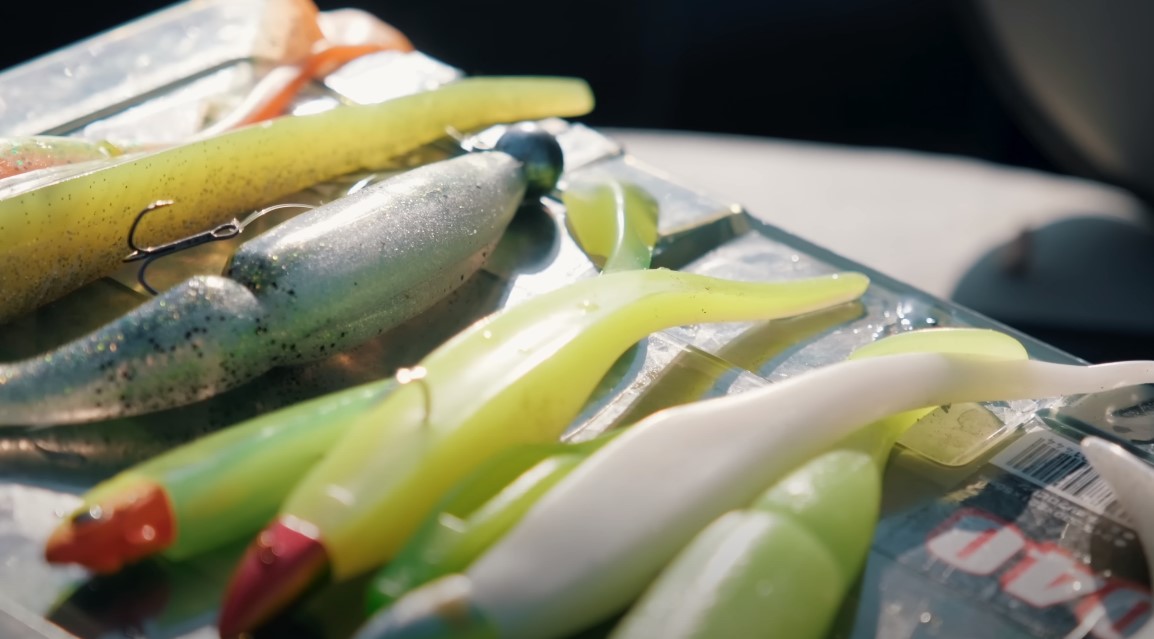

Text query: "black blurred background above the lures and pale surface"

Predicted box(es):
[0, 0, 1059, 171]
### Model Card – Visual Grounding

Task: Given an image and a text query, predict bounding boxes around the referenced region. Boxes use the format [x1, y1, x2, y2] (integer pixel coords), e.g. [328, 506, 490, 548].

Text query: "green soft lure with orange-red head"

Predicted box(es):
[45, 379, 395, 573]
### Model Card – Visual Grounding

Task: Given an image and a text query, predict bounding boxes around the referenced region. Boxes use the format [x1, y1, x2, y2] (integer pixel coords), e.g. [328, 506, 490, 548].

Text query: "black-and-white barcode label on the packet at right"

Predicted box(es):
[991, 430, 1130, 524]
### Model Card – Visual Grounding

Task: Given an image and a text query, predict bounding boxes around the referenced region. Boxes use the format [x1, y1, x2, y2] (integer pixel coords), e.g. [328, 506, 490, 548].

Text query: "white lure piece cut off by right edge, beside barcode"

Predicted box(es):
[1082, 437, 1154, 639]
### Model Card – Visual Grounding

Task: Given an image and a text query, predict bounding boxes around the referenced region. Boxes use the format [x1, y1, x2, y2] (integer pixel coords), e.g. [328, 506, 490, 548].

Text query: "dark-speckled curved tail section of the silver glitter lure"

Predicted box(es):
[0, 276, 268, 426]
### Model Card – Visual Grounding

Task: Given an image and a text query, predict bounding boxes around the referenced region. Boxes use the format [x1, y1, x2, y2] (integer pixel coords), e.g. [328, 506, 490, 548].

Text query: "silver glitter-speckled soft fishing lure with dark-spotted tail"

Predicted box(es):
[0, 128, 560, 424]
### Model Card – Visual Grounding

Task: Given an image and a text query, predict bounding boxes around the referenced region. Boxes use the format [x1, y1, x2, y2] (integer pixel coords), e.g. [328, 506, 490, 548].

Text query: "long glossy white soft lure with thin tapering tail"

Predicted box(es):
[362, 327, 1154, 638]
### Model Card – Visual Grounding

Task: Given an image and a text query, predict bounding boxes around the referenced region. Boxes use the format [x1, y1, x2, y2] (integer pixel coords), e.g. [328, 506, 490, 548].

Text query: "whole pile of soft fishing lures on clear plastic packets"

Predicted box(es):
[0, 0, 1154, 639]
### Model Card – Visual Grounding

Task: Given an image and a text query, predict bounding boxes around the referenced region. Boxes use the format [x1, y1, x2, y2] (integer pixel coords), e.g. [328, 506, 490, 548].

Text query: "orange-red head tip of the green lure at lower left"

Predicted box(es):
[44, 482, 177, 573]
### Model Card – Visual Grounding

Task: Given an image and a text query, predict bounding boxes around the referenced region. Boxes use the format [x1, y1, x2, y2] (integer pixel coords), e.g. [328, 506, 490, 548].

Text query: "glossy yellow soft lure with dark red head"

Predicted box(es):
[219, 270, 868, 636]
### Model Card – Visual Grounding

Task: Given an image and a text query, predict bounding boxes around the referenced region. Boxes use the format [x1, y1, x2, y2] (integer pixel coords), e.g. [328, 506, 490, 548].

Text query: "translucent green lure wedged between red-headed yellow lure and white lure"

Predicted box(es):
[366, 431, 620, 615]
